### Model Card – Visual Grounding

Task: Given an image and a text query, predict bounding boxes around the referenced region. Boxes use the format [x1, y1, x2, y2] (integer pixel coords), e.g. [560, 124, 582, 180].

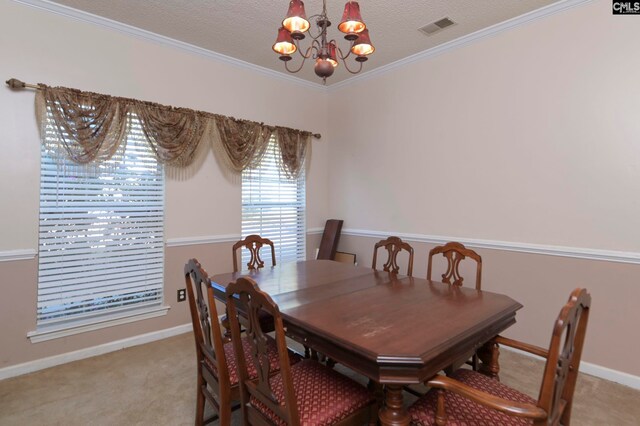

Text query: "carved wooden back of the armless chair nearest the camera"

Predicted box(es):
[227, 277, 300, 425]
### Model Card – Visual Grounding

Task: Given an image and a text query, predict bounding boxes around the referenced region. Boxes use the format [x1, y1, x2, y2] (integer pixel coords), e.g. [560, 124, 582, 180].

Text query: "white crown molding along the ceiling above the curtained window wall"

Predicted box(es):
[13, 0, 327, 92]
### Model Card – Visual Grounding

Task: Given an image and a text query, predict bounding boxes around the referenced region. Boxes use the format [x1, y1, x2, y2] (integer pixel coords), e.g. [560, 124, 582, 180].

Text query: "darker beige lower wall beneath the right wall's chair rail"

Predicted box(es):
[339, 235, 640, 376]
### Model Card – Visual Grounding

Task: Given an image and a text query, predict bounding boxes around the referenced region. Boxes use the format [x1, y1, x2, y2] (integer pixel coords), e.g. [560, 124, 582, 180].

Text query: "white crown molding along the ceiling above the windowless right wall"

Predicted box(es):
[327, 0, 593, 93]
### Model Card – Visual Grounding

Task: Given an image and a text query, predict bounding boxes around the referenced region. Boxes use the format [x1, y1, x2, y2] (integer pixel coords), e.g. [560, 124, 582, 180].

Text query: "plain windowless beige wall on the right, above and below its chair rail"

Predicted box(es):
[329, 0, 640, 376]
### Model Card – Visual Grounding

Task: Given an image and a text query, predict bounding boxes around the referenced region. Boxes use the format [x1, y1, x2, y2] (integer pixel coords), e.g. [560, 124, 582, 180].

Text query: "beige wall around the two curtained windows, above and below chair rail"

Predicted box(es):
[0, 0, 328, 368]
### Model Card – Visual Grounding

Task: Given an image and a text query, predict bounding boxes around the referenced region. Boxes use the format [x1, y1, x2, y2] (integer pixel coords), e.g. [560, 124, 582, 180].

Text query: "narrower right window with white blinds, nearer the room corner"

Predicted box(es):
[242, 136, 306, 264]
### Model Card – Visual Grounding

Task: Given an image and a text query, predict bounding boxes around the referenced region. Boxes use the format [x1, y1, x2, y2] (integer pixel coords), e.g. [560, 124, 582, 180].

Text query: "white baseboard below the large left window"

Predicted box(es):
[0, 323, 192, 380]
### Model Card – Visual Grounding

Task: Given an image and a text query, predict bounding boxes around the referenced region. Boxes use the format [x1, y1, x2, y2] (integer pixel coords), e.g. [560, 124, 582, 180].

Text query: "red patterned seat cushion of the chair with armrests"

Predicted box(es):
[409, 369, 537, 426]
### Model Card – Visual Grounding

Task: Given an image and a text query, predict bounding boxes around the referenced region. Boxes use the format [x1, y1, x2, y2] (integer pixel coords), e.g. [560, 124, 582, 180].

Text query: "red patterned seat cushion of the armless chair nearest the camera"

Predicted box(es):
[251, 359, 373, 426]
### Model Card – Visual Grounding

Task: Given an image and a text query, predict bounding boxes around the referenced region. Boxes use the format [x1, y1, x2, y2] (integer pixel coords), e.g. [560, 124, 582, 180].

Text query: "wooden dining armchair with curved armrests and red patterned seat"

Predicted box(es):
[409, 288, 591, 426]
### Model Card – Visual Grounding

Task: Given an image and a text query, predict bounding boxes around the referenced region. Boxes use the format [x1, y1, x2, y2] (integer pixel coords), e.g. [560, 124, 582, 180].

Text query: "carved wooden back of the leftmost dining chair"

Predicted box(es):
[184, 259, 235, 424]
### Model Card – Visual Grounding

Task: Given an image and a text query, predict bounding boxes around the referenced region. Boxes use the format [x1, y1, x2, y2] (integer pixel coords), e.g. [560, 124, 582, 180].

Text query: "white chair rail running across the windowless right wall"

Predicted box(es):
[342, 229, 640, 264]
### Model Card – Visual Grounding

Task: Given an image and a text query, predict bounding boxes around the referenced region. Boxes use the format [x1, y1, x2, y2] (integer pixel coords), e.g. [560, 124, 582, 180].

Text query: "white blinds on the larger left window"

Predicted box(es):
[37, 117, 164, 328]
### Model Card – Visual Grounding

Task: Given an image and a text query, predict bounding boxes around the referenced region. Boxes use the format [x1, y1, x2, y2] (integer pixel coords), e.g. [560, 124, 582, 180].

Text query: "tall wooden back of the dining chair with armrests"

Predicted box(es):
[538, 288, 591, 425]
